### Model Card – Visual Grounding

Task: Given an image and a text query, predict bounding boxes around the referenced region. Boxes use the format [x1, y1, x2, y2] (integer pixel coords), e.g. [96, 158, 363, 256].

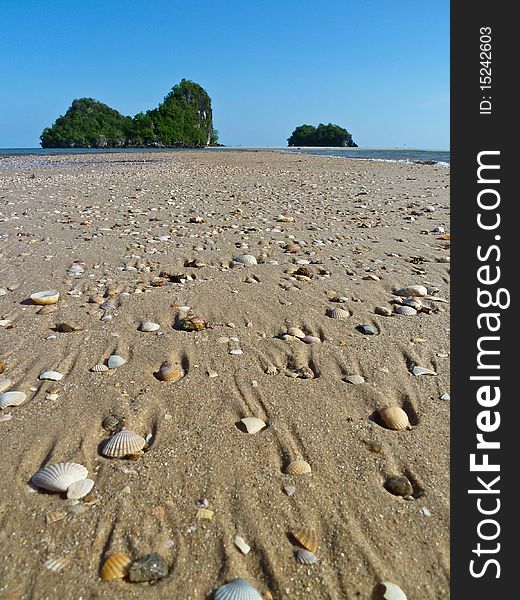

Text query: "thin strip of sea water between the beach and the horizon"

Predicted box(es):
[0, 146, 450, 168]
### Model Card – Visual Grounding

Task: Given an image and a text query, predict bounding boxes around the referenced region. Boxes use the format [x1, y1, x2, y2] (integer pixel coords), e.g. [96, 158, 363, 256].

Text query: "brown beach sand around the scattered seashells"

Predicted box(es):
[0, 152, 450, 600]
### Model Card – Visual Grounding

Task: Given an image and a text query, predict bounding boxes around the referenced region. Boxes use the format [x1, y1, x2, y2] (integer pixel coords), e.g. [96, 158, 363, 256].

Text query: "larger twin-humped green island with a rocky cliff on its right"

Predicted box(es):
[40, 79, 218, 148]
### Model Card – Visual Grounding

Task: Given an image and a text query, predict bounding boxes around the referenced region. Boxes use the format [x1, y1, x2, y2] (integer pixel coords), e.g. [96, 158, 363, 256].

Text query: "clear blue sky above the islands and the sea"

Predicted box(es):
[0, 0, 450, 149]
